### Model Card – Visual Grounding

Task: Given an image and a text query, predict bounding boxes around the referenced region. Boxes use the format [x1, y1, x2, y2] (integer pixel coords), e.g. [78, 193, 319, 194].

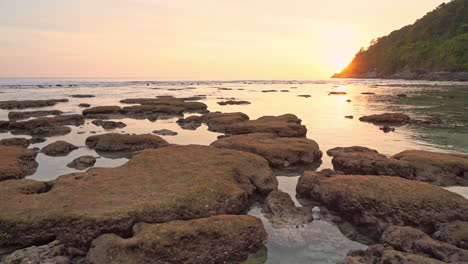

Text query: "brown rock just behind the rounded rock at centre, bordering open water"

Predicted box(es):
[221, 114, 307, 137]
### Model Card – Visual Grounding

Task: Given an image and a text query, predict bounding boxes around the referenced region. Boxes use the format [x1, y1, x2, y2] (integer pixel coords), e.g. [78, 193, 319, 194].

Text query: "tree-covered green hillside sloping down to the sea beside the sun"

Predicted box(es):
[333, 0, 468, 81]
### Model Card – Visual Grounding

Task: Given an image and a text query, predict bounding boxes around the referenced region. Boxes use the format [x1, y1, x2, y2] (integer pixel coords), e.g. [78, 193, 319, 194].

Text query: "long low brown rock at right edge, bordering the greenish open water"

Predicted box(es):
[329, 149, 468, 186]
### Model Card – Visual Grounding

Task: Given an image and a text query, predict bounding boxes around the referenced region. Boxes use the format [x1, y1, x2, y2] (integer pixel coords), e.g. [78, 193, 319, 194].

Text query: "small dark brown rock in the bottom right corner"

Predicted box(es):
[381, 226, 468, 263]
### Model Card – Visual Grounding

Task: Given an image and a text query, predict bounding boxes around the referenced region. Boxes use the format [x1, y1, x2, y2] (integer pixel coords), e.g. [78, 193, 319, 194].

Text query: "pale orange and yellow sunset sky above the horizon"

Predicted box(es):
[0, 0, 444, 80]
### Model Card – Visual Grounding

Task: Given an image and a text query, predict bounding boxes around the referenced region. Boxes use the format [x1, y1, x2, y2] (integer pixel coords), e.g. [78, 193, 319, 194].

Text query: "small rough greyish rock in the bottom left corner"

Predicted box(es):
[2, 240, 71, 264]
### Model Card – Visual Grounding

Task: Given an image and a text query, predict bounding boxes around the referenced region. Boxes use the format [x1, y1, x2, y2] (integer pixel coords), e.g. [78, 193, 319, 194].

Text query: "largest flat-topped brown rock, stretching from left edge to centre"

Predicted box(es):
[0, 145, 278, 249]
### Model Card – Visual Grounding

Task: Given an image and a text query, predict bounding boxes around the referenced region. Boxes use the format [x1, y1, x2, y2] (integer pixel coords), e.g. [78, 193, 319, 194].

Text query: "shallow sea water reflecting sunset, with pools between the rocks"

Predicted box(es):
[0, 79, 468, 263]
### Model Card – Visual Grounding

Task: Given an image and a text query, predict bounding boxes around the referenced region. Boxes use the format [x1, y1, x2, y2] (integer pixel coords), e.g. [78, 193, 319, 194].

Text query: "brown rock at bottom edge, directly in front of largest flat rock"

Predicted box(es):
[87, 215, 267, 264]
